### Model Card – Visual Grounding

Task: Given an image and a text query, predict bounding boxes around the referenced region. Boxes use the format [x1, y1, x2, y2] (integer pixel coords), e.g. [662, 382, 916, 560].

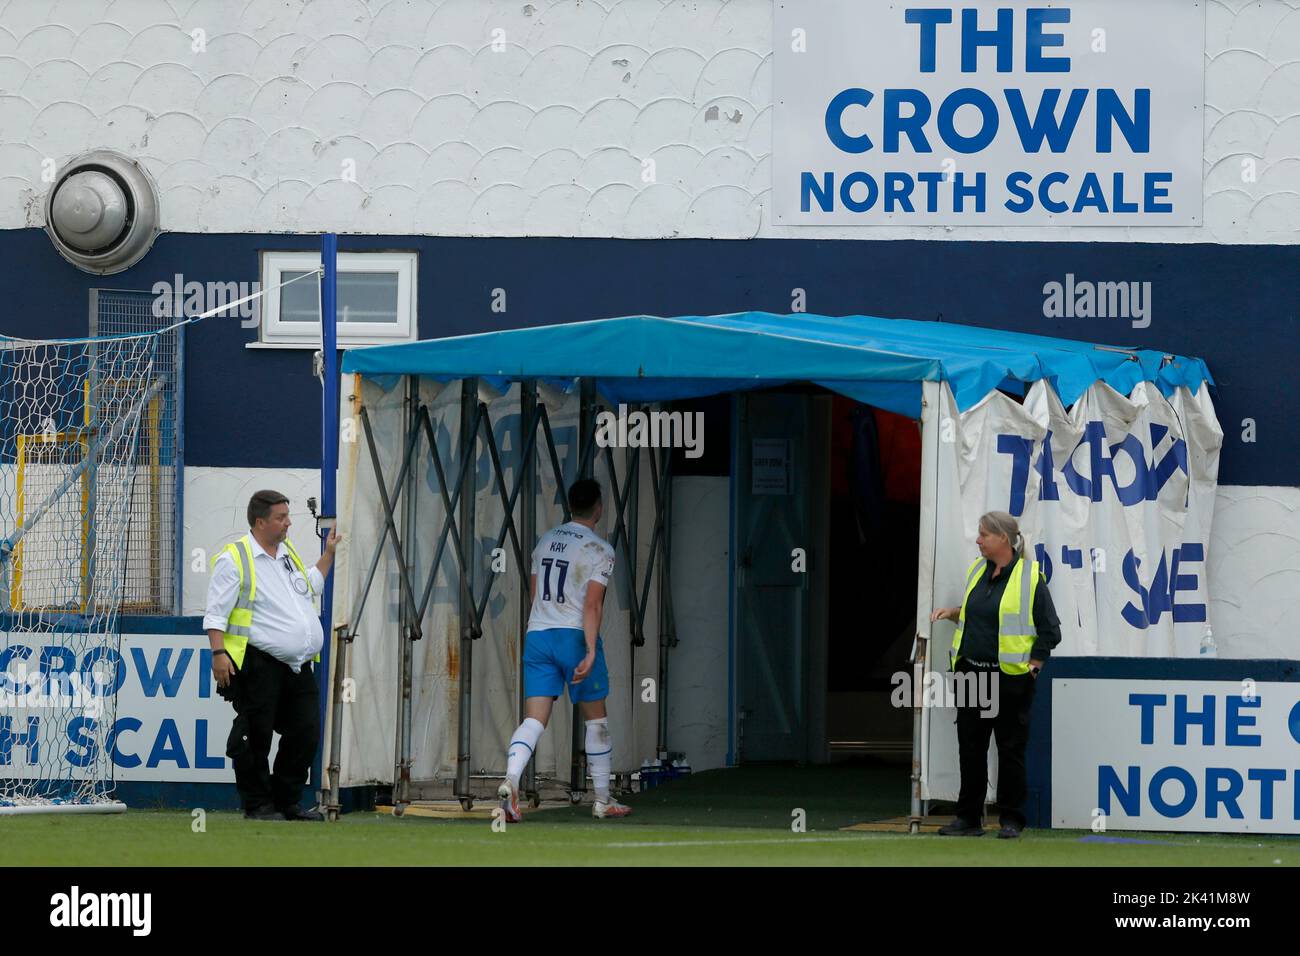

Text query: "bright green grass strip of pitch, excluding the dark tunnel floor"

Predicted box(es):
[0, 810, 1300, 866]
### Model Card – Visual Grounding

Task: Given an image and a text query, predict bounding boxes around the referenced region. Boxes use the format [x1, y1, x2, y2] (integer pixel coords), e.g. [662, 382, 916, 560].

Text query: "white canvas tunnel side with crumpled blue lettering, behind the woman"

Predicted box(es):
[913, 380, 1223, 812]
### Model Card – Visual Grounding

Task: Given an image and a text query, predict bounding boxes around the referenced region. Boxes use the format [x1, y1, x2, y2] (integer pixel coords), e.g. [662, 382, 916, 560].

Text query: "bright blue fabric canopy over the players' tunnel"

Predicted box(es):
[343, 312, 1214, 419]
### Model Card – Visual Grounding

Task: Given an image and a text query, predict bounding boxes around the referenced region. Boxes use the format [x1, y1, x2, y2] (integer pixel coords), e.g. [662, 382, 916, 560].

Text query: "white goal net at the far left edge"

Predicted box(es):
[0, 333, 165, 813]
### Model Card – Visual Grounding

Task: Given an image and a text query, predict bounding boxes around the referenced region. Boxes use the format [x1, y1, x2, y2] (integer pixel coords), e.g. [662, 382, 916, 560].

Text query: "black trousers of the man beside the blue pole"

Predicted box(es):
[218, 644, 320, 810]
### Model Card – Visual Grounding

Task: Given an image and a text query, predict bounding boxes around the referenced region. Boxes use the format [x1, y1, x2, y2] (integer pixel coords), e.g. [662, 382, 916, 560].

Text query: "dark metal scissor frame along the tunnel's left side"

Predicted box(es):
[326, 375, 677, 819]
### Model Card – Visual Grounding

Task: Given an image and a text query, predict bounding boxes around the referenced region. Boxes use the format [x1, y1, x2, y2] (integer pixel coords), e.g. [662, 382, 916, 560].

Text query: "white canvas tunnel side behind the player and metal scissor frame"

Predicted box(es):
[325, 375, 664, 796]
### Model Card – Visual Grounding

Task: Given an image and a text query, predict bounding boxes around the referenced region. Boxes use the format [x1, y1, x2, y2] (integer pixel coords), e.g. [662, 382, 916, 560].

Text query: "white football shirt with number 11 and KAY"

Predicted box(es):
[528, 522, 614, 631]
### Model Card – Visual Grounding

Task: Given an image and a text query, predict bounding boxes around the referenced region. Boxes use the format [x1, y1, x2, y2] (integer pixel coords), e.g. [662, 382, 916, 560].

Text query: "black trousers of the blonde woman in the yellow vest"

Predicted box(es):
[957, 659, 1037, 827]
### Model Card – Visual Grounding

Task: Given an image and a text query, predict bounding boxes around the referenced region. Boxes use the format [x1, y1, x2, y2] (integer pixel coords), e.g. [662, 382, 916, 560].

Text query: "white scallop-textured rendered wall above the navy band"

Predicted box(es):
[0, 0, 1300, 243]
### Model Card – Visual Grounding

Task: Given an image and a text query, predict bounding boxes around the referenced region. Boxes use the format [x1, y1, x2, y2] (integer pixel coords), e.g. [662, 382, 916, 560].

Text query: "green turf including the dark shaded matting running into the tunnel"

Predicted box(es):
[0, 767, 1300, 866]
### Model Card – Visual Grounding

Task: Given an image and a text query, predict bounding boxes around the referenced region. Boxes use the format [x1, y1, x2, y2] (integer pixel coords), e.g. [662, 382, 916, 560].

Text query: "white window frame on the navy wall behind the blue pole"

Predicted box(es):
[248, 250, 420, 349]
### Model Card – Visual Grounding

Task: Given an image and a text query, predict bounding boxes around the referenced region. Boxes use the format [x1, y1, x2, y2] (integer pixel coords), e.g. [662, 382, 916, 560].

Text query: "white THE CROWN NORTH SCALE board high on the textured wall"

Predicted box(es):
[772, 0, 1205, 226]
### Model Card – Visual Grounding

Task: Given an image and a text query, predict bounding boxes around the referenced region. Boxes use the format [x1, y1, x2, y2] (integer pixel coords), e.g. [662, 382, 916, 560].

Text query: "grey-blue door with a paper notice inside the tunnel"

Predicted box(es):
[732, 392, 831, 762]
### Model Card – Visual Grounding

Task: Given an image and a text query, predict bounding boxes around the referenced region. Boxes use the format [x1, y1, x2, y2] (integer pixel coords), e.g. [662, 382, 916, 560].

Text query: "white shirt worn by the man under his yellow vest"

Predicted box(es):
[203, 535, 325, 674]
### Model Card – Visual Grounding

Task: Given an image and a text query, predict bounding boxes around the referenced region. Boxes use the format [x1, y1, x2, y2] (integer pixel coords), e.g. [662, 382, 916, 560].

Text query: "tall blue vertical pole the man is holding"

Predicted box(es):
[312, 233, 338, 790]
